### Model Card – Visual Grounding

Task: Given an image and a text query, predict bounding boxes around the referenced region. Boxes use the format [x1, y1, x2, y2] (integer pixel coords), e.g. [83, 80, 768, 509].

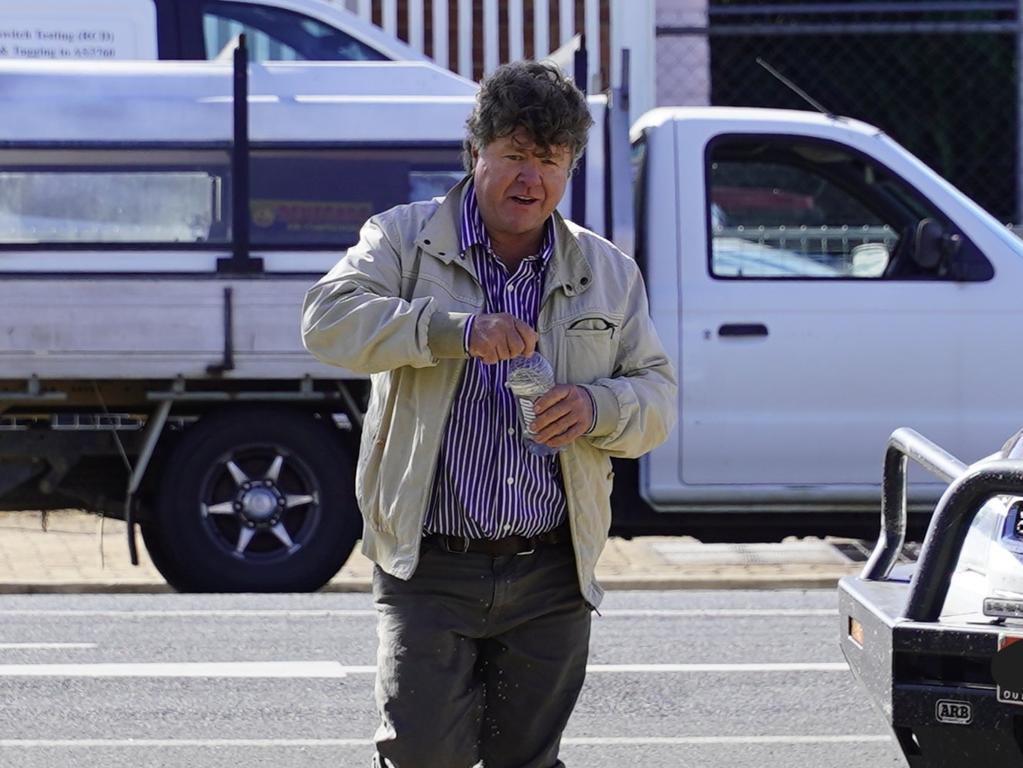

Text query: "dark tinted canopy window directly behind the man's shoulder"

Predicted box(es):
[251, 147, 464, 247]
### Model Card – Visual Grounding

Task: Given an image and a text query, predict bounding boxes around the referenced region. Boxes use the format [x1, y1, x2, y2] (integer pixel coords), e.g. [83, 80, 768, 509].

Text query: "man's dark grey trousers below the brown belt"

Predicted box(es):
[373, 544, 590, 768]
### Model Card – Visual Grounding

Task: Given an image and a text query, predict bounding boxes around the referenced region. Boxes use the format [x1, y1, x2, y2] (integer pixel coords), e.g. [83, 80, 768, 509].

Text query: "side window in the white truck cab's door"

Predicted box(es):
[708, 137, 986, 279]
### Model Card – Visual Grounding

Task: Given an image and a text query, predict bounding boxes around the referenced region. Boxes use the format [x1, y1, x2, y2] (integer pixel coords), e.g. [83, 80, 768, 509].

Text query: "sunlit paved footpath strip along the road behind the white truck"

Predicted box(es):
[0, 510, 864, 594]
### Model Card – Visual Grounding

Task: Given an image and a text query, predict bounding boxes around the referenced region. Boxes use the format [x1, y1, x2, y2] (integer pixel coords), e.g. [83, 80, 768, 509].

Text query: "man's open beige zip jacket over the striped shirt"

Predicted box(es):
[302, 181, 677, 606]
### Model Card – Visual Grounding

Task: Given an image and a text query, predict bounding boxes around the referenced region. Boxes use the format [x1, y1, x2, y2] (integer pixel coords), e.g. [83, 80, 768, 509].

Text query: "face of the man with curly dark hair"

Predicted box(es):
[473, 129, 572, 249]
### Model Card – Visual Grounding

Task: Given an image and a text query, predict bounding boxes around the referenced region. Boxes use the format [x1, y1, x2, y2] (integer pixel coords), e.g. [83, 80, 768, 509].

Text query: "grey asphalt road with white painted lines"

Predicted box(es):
[0, 590, 905, 768]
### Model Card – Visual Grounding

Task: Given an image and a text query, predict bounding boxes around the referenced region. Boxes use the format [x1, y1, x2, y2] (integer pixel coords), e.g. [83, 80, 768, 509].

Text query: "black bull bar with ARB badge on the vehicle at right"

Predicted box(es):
[838, 428, 1023, 768]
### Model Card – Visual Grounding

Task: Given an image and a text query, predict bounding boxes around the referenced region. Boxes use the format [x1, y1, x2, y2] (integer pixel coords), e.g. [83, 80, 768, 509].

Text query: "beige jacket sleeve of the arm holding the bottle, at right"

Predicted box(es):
[585, 269, 678, 458]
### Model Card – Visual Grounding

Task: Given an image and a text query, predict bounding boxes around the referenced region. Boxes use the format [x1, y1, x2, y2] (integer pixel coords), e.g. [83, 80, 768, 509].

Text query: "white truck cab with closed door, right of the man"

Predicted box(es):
[631, 108, 1023, 535]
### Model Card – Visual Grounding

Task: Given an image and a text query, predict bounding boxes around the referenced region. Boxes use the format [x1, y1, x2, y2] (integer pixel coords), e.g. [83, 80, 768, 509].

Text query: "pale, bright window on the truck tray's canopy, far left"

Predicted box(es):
[0, 149, 230, 244]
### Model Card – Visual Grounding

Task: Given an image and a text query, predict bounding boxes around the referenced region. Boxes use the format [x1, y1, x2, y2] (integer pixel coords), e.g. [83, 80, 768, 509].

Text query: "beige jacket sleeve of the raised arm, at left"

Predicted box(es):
[302, 217, 469, 373]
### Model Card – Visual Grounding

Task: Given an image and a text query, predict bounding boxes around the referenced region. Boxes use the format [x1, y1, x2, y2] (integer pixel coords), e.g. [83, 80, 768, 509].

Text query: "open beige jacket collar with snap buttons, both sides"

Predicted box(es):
[415, 174, 593, 302]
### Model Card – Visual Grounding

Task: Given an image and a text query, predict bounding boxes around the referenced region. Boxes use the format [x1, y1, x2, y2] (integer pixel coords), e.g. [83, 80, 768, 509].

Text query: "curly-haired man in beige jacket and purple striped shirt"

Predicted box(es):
[303, 62, 676, 768]
